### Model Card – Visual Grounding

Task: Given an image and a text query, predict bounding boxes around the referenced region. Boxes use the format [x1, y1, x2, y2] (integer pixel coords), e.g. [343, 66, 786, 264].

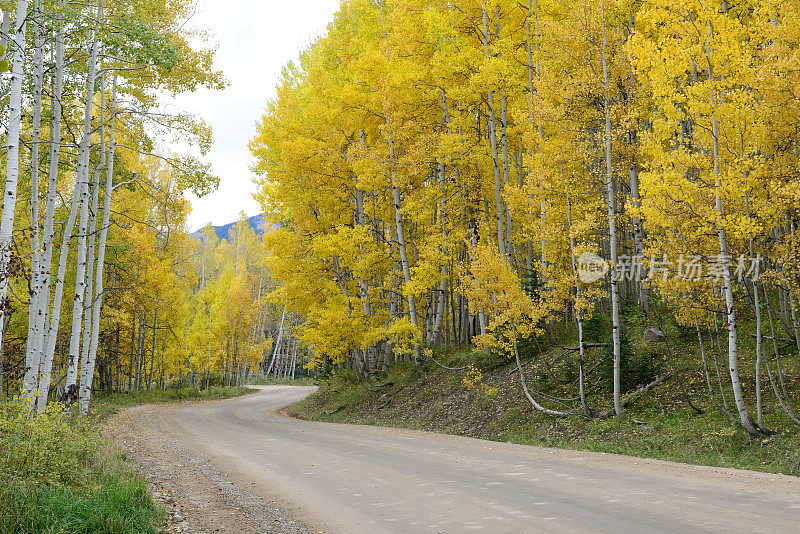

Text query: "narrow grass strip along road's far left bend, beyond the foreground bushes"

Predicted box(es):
[91, 386, 255, 420]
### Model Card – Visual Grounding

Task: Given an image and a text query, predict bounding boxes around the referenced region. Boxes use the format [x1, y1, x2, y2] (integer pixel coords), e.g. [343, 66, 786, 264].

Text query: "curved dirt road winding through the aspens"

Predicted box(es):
[147, 386, 800, 534]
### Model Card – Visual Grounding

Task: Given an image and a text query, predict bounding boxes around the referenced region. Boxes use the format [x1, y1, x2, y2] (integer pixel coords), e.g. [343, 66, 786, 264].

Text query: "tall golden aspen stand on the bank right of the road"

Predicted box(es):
[251, 0, 800, 437]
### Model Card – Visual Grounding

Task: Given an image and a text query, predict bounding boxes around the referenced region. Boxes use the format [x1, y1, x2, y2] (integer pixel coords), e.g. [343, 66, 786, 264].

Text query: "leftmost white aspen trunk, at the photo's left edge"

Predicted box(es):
[0, 0, 28, 346]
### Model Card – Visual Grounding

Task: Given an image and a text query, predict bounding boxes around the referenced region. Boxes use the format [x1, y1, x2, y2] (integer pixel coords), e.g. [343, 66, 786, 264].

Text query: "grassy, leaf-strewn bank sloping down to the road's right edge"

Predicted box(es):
[290, 351, 800, 476]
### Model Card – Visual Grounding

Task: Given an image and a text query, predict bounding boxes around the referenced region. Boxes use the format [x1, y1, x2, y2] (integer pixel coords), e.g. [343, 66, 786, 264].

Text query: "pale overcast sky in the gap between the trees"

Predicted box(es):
[176, 0, 339, 231]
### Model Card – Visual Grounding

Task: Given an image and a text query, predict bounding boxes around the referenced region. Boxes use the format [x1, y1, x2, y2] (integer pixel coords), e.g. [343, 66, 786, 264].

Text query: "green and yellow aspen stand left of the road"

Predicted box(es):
[0, 0, 307, 413]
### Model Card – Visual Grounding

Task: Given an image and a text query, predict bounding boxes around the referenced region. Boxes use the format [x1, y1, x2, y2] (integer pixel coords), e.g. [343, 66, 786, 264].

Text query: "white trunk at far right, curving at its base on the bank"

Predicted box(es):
[705, 21, 760, 436]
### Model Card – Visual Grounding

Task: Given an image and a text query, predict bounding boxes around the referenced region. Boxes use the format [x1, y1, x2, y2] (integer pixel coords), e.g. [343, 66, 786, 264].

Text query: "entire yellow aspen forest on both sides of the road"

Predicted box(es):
[0, 0, 800, 448]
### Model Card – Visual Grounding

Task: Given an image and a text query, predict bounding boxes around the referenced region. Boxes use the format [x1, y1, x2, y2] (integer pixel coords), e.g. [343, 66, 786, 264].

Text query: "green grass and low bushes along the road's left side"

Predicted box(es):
[0, 387, 253, 534]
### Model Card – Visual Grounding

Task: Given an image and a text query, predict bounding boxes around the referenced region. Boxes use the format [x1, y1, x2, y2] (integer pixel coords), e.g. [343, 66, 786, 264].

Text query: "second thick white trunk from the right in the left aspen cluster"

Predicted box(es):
[64, 0, 103, 402]
